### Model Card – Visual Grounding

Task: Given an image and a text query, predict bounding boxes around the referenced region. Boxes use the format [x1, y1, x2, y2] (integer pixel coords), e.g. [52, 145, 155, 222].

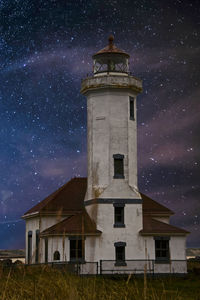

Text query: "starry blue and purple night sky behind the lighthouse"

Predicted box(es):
[0, 0, 200, 249]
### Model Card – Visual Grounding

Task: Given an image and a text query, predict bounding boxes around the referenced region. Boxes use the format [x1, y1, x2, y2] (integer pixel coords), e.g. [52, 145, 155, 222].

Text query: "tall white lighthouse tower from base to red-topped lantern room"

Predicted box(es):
[81, 36, 144, 261]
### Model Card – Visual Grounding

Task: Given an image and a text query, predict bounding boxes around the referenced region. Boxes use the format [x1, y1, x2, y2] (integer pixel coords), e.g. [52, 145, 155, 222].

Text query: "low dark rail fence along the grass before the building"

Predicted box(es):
[2, 259, 187, 275]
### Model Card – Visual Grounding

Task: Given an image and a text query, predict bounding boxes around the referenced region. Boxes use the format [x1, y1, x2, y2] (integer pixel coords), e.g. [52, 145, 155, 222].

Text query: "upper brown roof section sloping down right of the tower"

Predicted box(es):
[140, 193, 174, 216]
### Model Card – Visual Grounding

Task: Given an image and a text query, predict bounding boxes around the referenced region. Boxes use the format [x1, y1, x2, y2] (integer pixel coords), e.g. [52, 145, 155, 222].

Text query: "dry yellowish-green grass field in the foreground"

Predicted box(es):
[0, 266, 200, 300]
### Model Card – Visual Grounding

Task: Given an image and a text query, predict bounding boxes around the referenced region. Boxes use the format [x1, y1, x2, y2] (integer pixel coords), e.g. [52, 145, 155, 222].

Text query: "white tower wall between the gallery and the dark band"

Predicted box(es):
[86, 88, 139, 200]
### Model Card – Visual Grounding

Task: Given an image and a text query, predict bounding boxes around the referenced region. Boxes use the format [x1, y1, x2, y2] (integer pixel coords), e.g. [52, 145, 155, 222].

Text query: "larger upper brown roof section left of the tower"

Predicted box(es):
[24, 178, 87, 216]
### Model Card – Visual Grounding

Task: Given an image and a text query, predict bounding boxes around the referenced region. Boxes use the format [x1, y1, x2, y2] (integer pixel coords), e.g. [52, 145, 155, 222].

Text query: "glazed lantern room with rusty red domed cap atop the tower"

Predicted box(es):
[92, 35, 130, 76]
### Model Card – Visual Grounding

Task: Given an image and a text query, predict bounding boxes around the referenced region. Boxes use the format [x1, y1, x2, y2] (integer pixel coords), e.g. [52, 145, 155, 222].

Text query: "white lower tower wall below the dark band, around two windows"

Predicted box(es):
[86, 204, 145, 261]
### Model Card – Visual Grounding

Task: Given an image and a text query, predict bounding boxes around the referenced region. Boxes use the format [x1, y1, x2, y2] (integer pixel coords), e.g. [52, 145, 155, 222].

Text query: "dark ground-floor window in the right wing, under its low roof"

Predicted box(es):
[154, 237, 170, 261]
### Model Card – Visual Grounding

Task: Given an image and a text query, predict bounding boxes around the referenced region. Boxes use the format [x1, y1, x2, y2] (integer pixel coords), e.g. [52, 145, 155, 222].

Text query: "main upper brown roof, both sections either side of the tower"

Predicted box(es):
[24, 177, 173, 218]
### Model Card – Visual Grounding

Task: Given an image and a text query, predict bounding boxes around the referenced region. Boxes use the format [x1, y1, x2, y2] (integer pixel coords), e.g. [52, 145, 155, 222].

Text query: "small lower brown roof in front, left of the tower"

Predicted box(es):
[40, 210, 101, 236]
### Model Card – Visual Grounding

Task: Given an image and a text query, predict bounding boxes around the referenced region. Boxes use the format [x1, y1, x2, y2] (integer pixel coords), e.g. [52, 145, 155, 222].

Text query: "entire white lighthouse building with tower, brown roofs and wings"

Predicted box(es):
[23, 36, 188, 274]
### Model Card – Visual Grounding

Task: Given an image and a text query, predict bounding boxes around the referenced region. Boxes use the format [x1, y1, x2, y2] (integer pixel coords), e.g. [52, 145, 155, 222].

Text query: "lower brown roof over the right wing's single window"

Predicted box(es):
[140, 216, 189, 235]
